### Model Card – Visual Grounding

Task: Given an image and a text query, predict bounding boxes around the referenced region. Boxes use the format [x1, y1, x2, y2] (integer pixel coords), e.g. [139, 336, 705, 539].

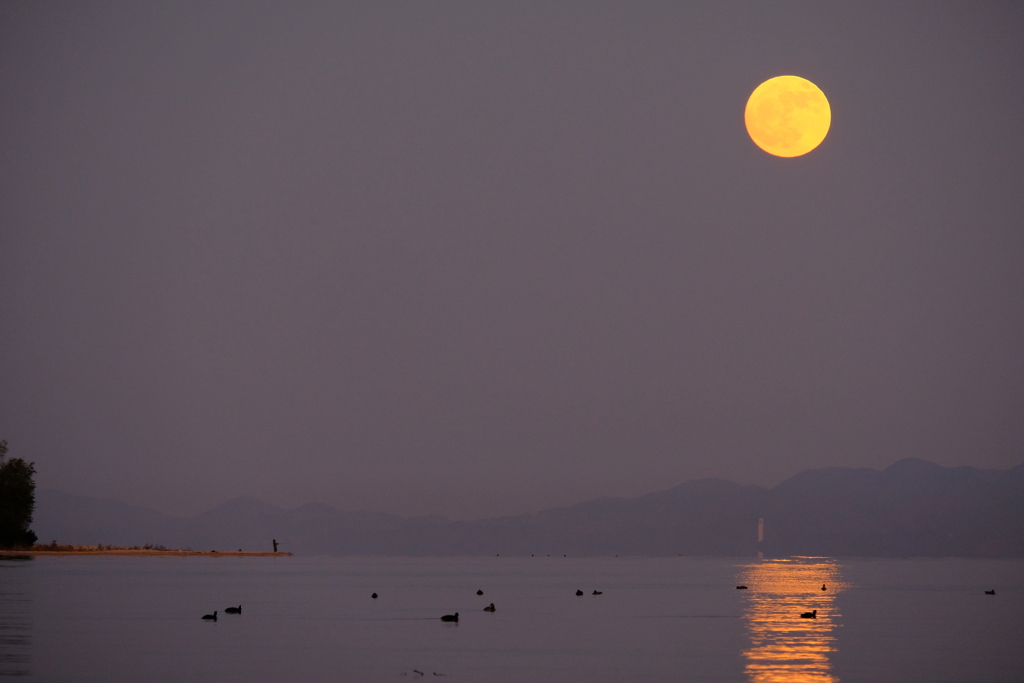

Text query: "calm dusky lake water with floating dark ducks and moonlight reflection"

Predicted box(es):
[0, 557, 1024, 683]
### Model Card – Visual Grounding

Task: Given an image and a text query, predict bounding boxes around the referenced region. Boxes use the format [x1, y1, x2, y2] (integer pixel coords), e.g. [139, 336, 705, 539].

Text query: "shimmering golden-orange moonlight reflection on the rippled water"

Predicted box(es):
[737, 557, 848, 683]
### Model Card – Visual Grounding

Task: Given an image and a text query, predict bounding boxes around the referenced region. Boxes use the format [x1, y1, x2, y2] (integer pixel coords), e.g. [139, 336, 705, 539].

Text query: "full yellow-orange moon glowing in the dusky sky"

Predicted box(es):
[743, 76, 831, 157]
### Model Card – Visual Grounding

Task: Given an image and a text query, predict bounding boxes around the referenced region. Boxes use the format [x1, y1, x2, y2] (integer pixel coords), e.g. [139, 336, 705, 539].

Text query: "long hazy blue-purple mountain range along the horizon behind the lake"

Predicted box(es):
[33, 458, 1024, 557]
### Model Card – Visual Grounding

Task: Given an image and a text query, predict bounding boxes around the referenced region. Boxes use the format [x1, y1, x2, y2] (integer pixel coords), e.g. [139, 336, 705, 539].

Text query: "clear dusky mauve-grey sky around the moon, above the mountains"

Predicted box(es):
[0, 0, 1024, 518]
